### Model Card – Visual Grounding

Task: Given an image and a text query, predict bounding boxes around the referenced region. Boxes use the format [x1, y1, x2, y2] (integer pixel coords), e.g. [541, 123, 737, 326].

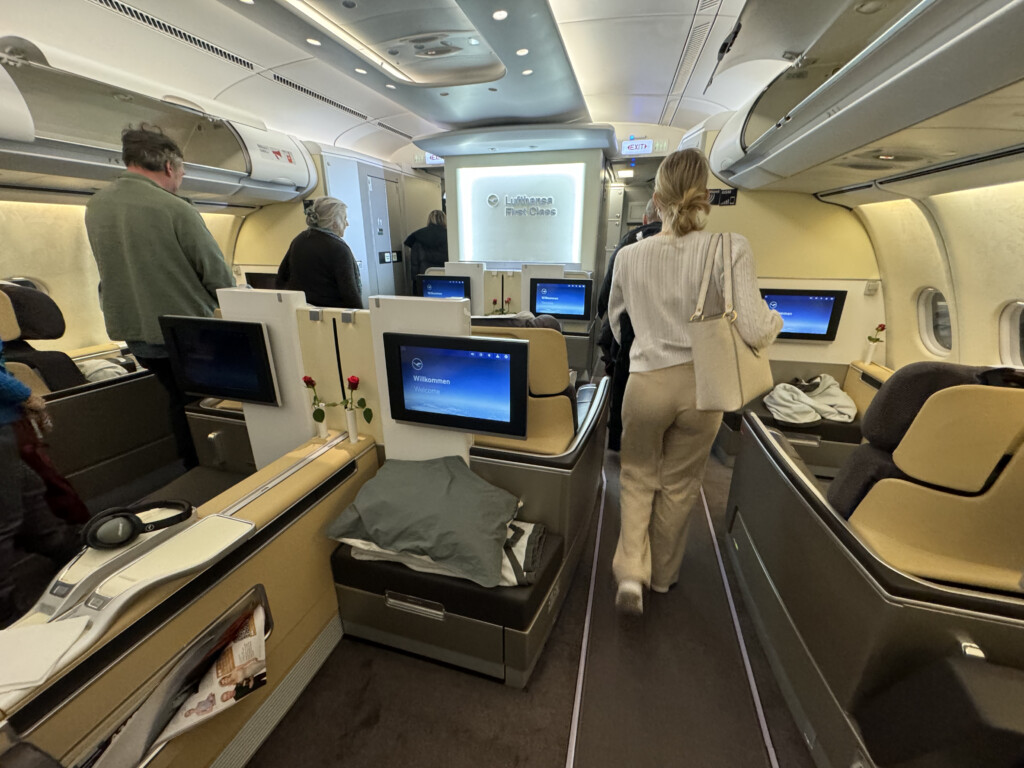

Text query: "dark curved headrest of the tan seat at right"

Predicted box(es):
[861, 362, 988, 453]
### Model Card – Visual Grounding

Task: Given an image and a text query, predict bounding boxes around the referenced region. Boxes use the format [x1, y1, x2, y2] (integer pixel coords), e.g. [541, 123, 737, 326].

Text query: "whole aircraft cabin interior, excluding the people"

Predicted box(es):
[0, 0, 1024, 768]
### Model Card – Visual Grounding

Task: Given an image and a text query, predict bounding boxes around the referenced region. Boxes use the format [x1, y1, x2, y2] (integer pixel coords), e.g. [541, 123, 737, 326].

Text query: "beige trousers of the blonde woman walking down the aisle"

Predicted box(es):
[611, 364, 722, 592]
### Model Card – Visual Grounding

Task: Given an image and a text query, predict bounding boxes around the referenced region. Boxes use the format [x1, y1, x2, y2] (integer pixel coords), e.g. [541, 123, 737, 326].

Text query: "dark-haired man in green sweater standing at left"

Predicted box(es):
[85, 125, 234, 467]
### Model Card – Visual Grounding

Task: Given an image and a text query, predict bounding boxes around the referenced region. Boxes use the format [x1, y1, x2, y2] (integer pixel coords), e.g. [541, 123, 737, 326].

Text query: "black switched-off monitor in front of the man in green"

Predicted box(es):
[160, 314, 281, 406]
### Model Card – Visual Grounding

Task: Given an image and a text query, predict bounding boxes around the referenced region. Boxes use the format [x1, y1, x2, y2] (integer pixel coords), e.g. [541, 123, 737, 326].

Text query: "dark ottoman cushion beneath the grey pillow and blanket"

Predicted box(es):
[331, 532, 564, 631]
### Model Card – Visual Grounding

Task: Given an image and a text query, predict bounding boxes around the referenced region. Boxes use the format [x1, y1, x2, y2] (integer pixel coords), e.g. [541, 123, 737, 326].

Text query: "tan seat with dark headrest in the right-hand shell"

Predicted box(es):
[827, 362, 1024, 592]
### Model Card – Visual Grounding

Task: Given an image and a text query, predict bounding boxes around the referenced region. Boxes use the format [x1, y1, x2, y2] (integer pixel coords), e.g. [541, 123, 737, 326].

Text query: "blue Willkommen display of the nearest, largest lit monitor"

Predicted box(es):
[399, 345, 512, 422]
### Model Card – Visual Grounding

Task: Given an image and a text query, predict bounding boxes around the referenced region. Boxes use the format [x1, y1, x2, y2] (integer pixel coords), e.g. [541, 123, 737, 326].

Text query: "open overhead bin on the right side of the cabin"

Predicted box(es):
[712, 0, 1024, 193]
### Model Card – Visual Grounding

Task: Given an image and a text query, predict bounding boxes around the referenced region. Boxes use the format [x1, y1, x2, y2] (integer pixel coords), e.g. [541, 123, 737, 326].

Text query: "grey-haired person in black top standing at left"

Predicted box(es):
[278, 198, 362, 309]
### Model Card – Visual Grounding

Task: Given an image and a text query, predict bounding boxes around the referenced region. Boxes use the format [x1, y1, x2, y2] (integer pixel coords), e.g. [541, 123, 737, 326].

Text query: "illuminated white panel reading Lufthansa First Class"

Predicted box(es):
[456, 163, 586, 263]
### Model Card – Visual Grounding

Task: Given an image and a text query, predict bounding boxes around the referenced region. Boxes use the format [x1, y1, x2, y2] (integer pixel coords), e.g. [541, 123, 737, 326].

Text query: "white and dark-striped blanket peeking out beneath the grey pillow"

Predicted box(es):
[339, 520, 547, 587]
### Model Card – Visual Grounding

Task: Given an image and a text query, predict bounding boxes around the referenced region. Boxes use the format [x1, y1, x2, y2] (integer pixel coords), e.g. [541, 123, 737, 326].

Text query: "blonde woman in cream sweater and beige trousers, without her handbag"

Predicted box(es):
[608, 150, 782, 613]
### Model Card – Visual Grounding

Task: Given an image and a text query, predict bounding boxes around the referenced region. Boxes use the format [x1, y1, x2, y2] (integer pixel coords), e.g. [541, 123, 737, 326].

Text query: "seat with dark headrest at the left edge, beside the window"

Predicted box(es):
[0, 283, 87, 394]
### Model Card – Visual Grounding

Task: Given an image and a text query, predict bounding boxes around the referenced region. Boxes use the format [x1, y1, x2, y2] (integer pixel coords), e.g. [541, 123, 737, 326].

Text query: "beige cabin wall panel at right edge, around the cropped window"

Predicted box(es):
[923, 182, 1024, 366]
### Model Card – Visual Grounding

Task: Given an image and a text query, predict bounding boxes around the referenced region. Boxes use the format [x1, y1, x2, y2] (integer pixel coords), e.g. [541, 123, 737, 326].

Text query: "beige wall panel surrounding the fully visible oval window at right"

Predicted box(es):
[856, 200, 959, 368]
